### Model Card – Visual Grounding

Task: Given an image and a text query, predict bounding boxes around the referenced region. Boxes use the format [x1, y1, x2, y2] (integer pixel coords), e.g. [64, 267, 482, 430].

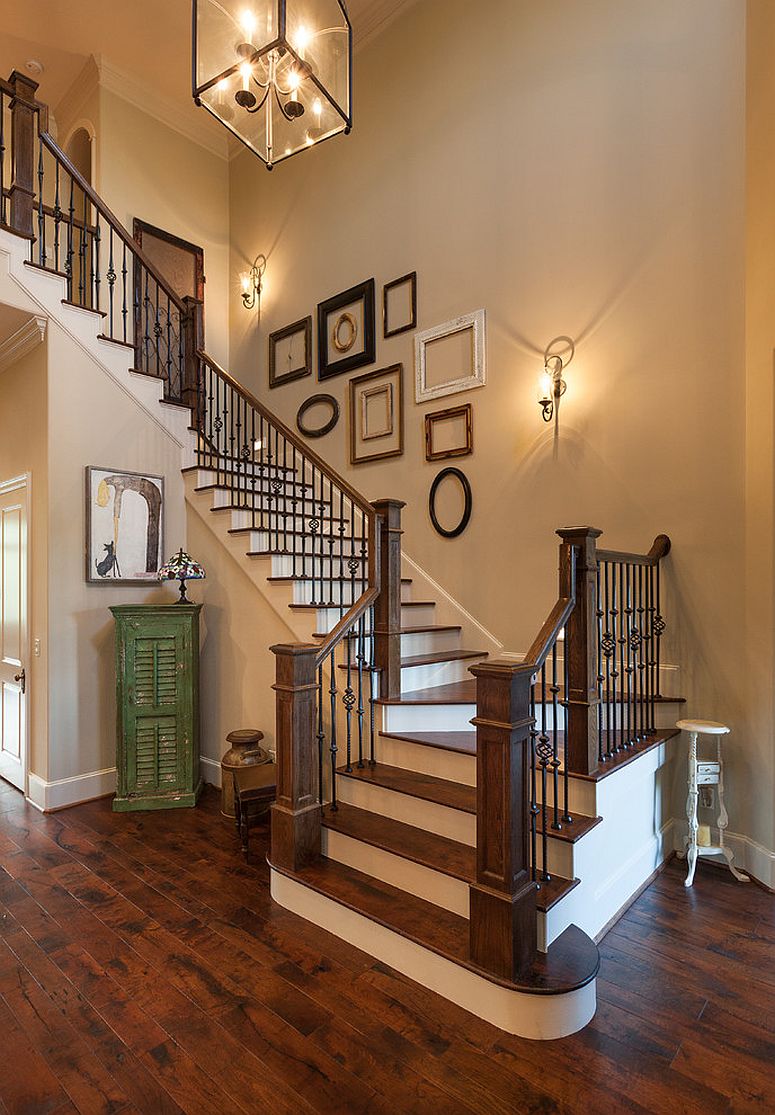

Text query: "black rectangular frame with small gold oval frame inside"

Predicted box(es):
[318, 279, 377, 379]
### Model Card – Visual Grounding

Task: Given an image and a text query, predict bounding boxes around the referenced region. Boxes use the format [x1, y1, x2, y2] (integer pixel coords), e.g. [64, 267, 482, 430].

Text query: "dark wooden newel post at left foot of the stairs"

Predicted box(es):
[271, 643, 321, 871]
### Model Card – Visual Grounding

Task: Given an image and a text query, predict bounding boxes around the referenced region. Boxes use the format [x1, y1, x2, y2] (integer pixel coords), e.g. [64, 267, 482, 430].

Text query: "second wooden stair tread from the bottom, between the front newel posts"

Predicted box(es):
[322, 802, 476, 883]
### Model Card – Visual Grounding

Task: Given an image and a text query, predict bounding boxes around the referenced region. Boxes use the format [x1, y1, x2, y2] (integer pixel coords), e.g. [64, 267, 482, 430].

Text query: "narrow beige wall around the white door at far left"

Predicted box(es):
[0, 343, 49, 778]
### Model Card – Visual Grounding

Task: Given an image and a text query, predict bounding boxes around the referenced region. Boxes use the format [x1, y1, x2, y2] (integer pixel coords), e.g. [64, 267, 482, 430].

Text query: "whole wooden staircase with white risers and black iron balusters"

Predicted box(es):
[0, 75, 680, 1038]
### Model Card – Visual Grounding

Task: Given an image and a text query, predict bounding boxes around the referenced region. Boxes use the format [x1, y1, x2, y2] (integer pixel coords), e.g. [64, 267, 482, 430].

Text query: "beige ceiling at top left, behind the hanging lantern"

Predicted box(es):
[0, 0, 413, 140]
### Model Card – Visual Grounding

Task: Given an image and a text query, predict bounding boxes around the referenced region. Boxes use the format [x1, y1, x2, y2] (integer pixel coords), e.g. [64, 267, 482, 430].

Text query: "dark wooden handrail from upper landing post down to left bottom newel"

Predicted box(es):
[197, 350, 380, 666]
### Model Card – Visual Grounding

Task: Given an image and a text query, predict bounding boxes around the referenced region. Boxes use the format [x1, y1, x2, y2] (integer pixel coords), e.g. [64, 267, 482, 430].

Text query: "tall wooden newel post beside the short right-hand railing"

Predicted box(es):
[556, 526, 602, 774]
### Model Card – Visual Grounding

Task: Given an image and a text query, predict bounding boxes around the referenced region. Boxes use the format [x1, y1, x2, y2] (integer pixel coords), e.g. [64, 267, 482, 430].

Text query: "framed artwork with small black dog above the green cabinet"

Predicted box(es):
[86, 466, 164, 584]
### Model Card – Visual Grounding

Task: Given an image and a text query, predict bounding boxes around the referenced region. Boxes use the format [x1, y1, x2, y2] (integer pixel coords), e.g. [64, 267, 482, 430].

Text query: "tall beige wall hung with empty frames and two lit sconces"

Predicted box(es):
[230, 0, 775, 847]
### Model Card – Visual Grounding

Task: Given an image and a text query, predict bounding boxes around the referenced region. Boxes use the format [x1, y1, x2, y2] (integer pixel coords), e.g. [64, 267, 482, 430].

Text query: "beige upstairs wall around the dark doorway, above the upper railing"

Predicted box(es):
[97, 88, 229, 362]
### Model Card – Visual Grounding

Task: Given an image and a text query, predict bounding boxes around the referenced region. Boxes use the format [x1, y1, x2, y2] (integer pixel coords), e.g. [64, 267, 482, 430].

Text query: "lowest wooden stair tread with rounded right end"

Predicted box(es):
[270, 857, 600, 995]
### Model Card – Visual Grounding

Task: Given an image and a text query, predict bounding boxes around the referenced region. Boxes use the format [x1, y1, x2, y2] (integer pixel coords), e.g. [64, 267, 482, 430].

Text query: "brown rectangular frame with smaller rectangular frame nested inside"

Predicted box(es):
[349, 363, 404, 465]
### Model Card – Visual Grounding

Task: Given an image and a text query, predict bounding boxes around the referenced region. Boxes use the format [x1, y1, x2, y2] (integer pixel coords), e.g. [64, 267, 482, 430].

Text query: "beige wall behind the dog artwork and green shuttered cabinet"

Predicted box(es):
[48, 322, 186, 781]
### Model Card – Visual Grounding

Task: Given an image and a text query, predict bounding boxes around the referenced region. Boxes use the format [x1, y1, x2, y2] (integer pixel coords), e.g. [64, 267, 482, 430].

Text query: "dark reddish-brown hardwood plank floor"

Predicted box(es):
[0, 782, 775, 1115]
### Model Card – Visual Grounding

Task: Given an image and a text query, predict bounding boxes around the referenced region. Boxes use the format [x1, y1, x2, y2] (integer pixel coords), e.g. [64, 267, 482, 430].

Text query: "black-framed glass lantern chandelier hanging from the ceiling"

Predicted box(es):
[192, 0, 352, 169]
